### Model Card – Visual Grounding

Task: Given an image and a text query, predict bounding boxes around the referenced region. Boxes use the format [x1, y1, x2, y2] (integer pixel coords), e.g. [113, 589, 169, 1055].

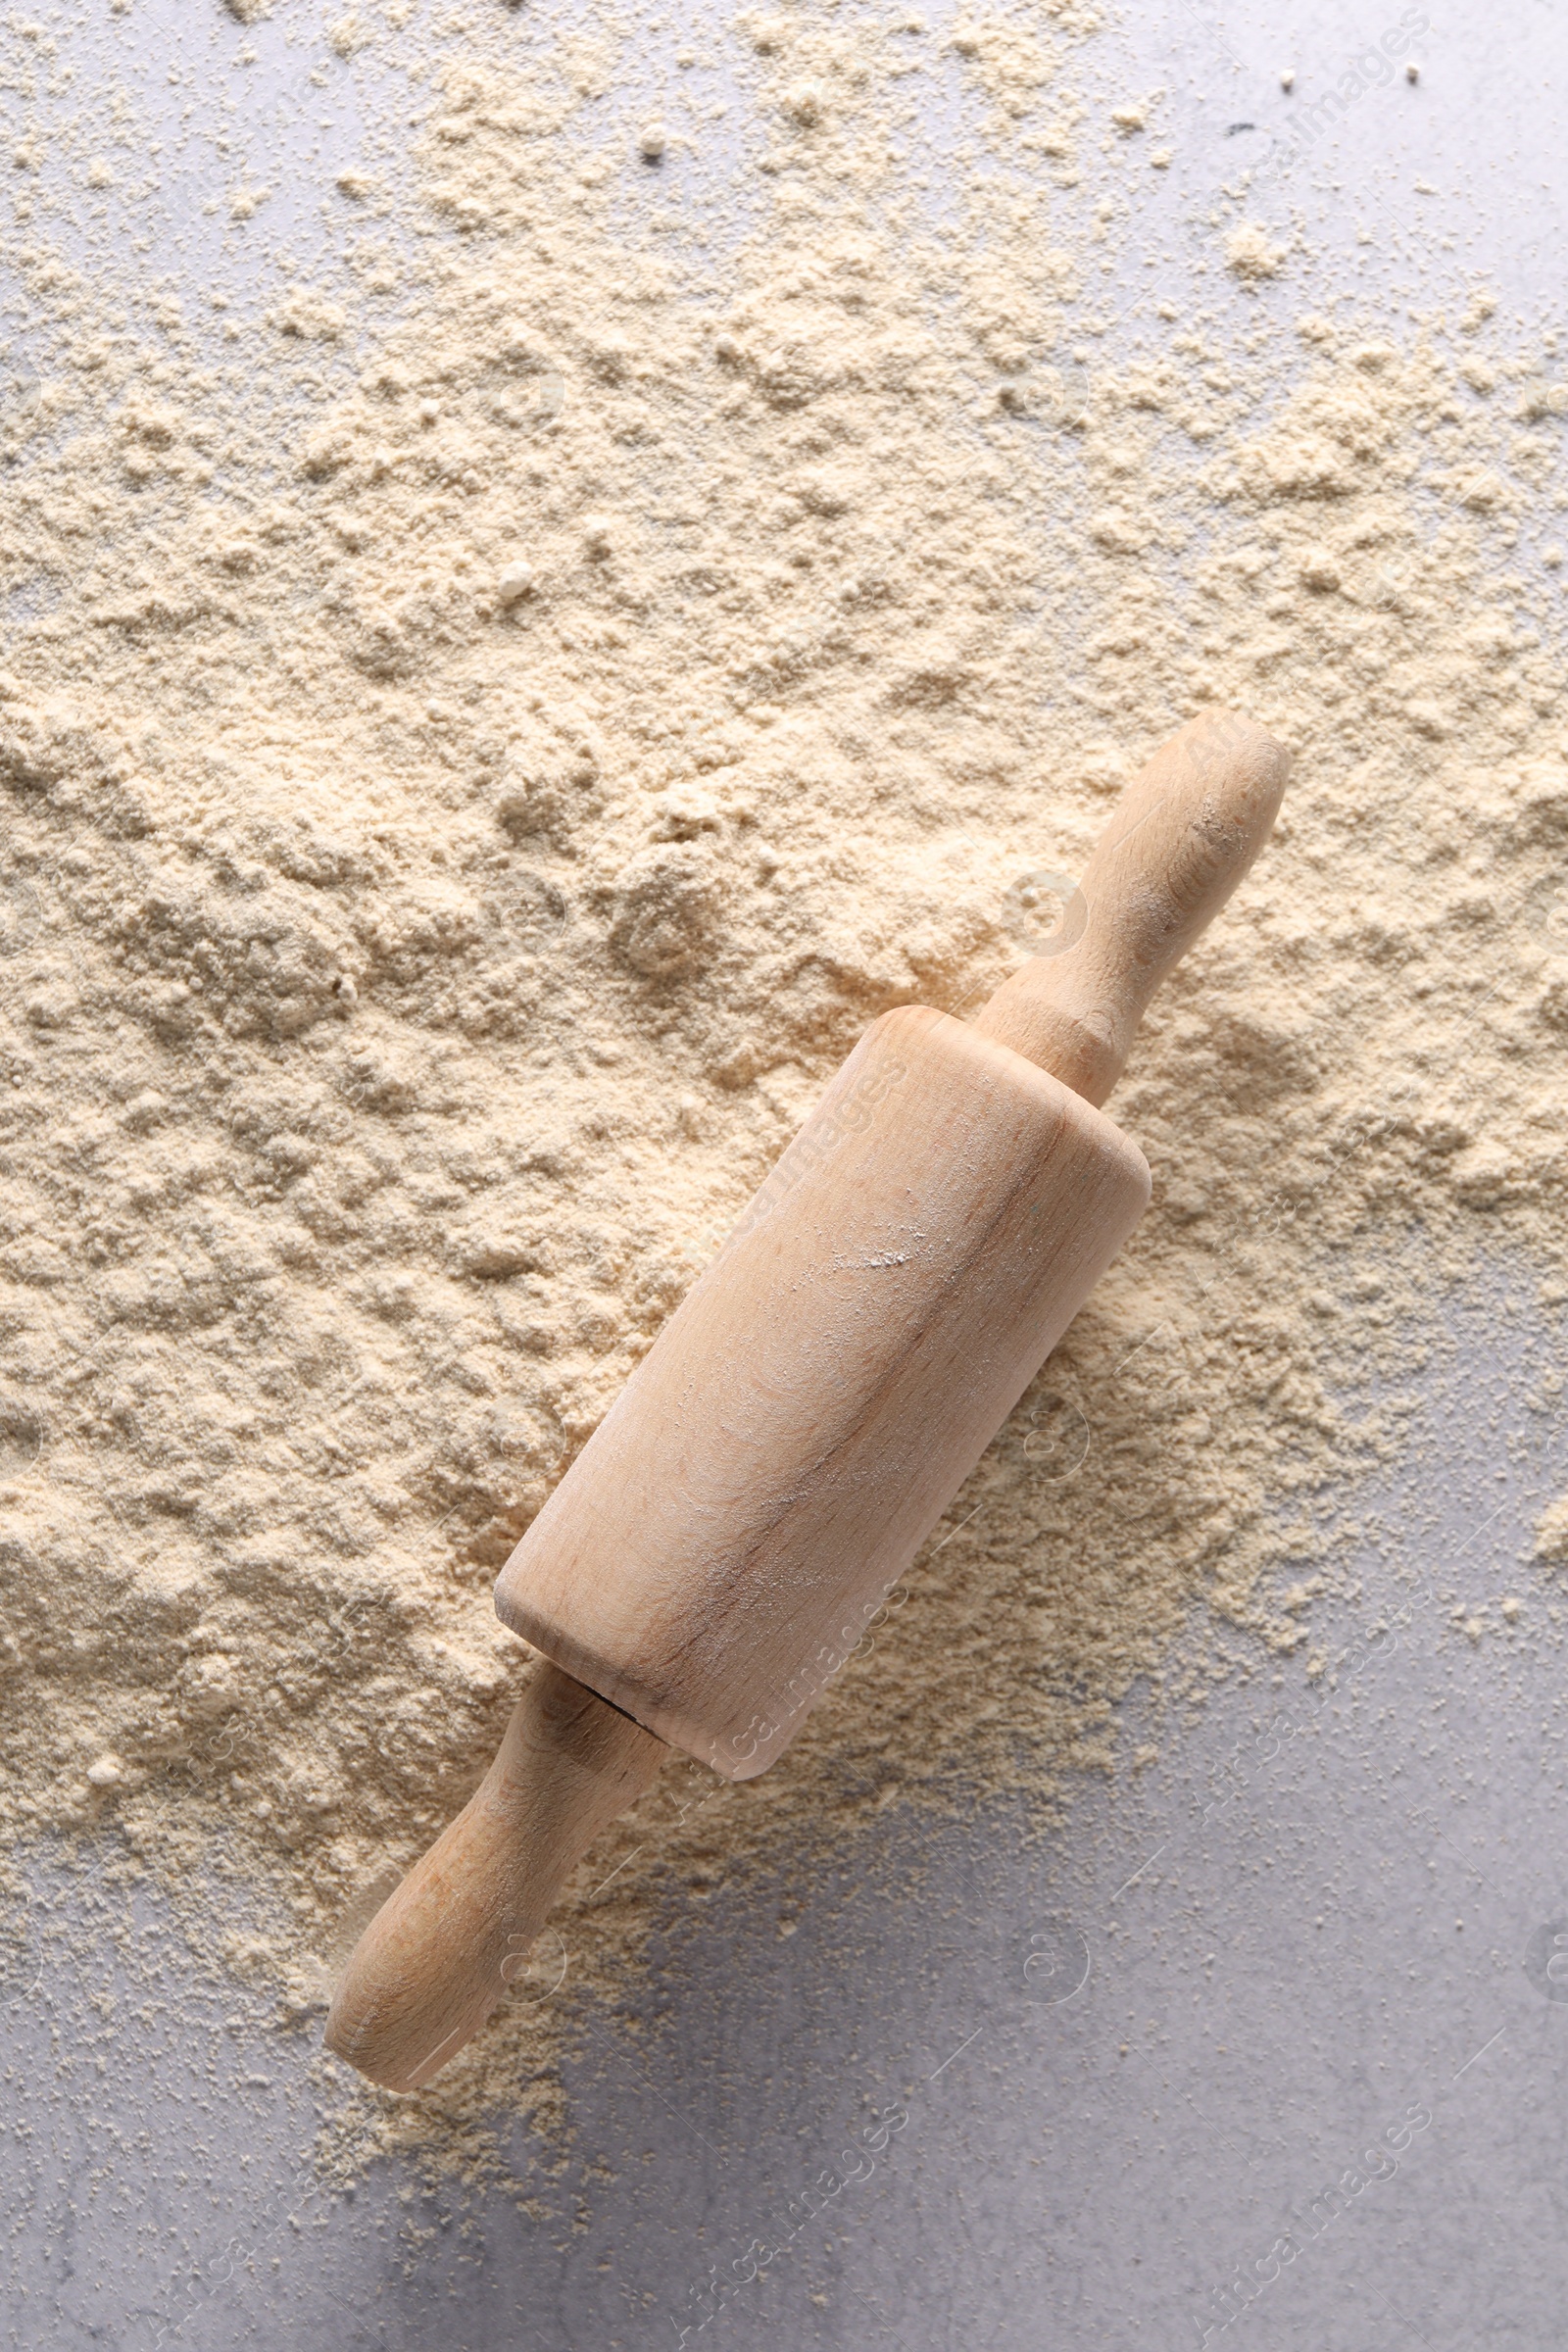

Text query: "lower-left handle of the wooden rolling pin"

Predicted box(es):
[326, 1663, 670, 2091]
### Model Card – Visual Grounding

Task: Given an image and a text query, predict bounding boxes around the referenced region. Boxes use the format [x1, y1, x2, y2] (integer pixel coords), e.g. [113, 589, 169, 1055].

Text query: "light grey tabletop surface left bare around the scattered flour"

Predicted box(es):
[0, 0, 1568, 2352]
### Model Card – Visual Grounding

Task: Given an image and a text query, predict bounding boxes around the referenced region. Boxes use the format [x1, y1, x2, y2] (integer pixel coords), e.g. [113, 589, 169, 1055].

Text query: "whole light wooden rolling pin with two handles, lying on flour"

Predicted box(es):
[326, 712, 1291, 2091]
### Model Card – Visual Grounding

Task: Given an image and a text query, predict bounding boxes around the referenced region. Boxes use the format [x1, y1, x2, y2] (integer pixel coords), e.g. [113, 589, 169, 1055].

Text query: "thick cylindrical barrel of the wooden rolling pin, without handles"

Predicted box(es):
[496, 1006, 1150, 1781]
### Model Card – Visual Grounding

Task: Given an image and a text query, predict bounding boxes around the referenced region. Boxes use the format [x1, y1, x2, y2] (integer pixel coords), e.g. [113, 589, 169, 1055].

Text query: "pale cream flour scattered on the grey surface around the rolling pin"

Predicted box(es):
[0, 0, 1568, 2162]
